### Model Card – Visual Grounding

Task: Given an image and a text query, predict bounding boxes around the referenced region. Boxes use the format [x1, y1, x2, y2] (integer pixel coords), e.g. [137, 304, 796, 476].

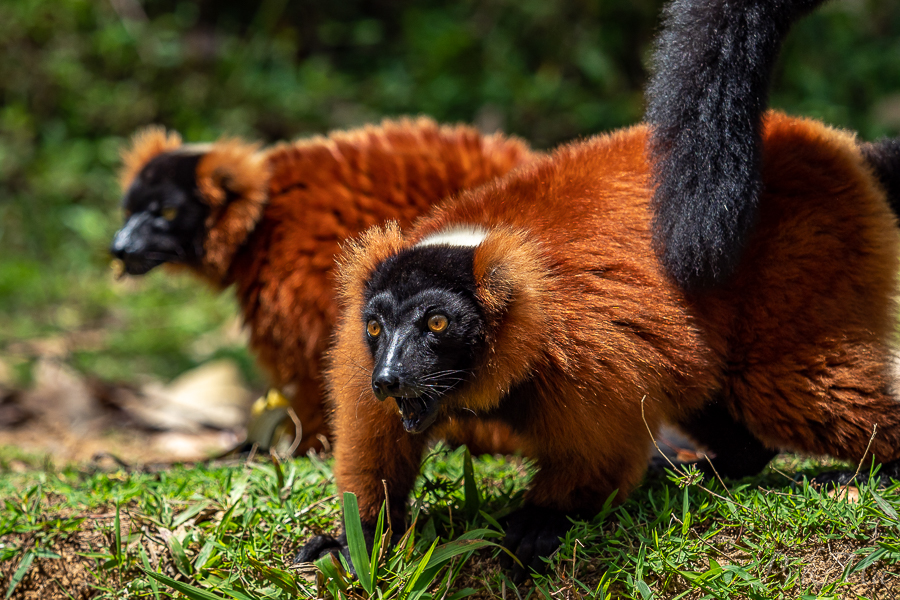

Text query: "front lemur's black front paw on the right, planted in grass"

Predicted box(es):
[500, 506, 572, 583]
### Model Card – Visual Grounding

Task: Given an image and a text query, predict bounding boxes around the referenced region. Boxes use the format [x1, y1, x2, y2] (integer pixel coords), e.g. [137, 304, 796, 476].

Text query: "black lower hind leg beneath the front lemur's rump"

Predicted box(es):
[679, 401, 778, 479]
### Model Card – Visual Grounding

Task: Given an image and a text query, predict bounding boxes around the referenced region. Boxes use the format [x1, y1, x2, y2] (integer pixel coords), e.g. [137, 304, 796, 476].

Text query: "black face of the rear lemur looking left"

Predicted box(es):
[109, 151, 209, 275]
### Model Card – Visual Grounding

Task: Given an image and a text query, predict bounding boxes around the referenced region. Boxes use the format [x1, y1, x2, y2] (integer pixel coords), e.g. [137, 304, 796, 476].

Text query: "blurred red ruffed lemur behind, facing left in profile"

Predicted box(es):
[111, 118, 534, 453]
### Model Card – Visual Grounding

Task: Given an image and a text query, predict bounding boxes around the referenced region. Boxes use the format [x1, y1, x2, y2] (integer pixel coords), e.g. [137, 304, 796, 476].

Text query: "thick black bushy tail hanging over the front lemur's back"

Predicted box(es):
[646, 0, 824, 291]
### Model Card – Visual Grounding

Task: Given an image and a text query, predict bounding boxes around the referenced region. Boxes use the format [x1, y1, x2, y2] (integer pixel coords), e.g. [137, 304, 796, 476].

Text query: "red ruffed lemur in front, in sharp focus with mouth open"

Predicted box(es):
[296, 0, 900, 579]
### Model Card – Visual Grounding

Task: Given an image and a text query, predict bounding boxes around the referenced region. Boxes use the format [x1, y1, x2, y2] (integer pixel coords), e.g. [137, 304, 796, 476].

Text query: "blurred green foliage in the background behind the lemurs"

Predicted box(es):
[0, 0, 900, 378]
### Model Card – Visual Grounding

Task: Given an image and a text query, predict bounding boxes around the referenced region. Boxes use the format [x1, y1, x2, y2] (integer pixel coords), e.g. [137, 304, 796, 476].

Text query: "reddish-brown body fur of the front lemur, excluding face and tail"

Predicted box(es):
[329, 113, 900, 521]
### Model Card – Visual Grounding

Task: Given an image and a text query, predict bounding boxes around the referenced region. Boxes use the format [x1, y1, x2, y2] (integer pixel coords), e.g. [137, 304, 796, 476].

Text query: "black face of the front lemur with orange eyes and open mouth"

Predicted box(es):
[360, 246, 485, 433]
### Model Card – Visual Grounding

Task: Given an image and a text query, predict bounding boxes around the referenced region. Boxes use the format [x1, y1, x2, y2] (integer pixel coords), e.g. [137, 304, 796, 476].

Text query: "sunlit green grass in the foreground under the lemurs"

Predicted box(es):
[0, 447, 900, 600]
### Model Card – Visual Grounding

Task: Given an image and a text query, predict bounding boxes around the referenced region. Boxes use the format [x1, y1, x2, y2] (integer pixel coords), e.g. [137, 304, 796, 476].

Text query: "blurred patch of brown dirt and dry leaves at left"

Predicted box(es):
[0, 360, 253, 468]
